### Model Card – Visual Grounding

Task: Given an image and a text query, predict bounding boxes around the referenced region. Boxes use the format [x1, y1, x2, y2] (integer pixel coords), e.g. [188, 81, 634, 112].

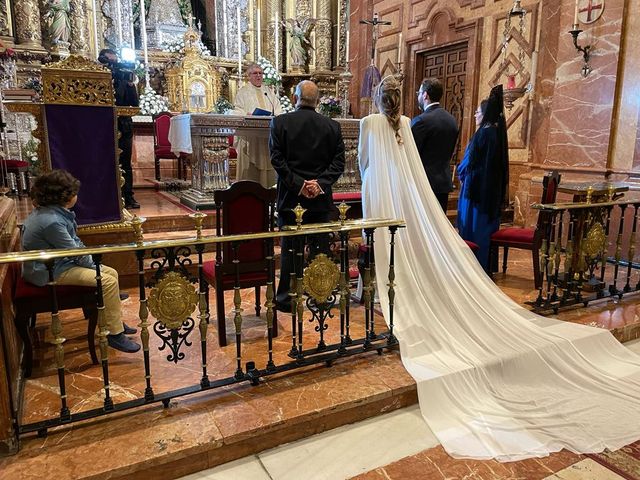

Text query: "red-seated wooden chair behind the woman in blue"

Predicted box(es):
[489, 171, 560, 288]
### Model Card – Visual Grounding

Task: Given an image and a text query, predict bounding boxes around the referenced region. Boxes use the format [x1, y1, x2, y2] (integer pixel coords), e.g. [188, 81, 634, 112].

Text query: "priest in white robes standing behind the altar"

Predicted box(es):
[233, 63, 282, 188]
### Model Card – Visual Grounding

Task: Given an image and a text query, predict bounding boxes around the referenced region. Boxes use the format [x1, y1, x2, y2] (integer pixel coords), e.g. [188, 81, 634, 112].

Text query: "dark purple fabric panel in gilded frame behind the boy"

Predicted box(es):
[45, 105, 121, 225]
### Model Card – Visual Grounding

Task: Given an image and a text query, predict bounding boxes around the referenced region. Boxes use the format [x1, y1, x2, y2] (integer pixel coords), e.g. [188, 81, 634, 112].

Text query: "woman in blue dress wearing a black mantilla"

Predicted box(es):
[458, 85, 509, 272]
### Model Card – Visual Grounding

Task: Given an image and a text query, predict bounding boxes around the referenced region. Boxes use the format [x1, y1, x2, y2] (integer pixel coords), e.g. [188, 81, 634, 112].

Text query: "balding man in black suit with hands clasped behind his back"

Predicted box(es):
[269, 80, 344, 312]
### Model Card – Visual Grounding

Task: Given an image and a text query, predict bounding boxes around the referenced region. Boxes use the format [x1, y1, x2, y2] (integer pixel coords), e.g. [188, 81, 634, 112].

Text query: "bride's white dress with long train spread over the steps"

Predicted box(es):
[359, 114, 640, 461]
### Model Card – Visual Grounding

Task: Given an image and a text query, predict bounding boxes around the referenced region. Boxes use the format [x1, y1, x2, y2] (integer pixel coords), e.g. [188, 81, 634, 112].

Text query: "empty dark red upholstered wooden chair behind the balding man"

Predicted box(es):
[203, 180, 278, 347]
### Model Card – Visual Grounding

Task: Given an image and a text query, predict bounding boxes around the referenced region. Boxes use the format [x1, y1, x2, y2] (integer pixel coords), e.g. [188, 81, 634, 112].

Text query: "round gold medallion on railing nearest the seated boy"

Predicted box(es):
[149, 272, 198, 330]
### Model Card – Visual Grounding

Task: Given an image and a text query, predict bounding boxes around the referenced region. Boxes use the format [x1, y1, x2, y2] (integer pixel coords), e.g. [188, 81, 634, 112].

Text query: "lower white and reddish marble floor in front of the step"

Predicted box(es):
[182, 340, 640, 480]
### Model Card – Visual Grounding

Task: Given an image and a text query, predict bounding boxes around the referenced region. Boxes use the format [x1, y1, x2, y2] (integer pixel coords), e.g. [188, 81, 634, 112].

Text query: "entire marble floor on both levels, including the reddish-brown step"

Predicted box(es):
[7, 190, 640, 480]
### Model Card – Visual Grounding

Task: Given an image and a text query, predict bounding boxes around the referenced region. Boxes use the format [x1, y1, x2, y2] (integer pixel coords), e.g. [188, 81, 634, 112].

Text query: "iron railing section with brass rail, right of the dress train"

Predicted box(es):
[530, 200, 640, 314]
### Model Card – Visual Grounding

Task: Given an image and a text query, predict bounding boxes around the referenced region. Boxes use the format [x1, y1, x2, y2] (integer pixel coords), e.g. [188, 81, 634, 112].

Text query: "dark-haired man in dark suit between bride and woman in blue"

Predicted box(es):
[411, 78, 458, 213]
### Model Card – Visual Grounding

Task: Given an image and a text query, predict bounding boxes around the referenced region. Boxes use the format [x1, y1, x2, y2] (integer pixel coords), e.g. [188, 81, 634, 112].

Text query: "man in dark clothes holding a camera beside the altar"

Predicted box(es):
[98, 48, 140, 210]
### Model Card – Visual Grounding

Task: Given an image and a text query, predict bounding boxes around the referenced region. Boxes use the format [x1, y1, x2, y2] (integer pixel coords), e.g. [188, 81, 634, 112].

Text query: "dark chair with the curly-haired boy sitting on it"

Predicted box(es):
[11, 265, 98, 377]
